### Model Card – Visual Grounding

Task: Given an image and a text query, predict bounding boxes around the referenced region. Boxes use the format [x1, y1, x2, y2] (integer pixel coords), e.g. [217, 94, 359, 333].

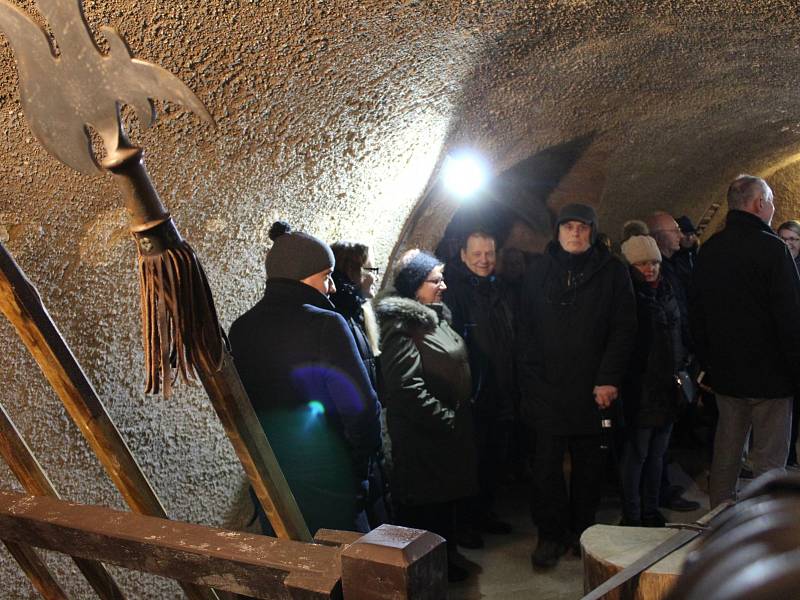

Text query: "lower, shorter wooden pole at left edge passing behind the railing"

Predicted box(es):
[0, 403, 125, 600]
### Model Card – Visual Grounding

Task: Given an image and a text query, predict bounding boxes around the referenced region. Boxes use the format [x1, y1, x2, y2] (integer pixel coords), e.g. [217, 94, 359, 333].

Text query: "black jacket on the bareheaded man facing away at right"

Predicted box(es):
[689, 210, 800, 398]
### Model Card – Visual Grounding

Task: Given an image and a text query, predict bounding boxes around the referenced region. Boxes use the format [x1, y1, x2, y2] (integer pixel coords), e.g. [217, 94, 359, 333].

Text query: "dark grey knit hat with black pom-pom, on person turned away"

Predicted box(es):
[266, 221, 336, 281]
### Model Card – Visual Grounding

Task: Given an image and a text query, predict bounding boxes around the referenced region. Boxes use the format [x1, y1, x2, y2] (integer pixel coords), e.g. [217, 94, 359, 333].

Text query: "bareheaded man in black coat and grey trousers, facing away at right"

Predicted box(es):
[689, 175, 800, 508]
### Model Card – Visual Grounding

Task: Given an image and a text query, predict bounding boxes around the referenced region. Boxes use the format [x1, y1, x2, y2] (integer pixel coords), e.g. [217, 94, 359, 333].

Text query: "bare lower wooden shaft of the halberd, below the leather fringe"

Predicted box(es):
[198, 350, 312, 542]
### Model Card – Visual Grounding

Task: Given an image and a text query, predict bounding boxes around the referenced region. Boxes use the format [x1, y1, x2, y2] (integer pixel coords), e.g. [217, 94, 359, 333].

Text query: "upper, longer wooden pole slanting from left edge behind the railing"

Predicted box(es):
[0, 243, 216, 600]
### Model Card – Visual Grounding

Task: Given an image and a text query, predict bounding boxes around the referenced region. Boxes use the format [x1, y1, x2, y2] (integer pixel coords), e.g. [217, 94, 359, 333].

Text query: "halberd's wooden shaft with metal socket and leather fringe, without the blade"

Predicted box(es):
[108, 146, 312, 542]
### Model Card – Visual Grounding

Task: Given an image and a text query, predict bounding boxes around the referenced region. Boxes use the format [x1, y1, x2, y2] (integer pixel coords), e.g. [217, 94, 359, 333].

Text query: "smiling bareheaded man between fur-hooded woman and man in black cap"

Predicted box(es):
[444, 230, 518, 547]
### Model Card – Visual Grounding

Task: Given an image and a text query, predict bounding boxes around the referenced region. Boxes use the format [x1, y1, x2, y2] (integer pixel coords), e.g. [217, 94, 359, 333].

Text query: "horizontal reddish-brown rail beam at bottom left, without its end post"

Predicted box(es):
[0, 490, 342, 600]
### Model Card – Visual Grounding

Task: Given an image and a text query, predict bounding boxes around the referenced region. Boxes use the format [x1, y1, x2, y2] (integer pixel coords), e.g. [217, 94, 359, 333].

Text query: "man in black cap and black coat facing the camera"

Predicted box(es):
[518, 204, 636, 567]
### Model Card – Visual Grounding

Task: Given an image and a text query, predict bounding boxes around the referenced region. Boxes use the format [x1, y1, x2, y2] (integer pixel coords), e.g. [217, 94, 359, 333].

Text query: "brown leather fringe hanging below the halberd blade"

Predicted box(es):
[139, 240, 226, 398]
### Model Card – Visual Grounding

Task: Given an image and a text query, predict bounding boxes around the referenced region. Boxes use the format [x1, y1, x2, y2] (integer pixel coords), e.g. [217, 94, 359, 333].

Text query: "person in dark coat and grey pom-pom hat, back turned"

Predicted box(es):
[230, 222, 381, 534]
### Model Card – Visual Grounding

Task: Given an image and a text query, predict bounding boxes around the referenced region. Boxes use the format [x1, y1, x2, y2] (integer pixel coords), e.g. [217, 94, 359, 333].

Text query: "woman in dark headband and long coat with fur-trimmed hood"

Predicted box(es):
[376, 250, 477, 581]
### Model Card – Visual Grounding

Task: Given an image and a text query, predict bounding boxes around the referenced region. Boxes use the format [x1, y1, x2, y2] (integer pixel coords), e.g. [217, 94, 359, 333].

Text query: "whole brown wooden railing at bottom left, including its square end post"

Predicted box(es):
[0, 490, 447, 600]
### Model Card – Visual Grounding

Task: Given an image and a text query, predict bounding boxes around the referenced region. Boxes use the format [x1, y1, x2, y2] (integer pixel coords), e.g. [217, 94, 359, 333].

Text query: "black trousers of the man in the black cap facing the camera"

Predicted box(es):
[531, 430, 607, 541]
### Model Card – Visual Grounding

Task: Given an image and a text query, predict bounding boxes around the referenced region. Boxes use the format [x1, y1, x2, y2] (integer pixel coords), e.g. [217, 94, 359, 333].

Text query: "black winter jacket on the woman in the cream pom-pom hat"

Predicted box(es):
[622, 268, 687, 427]
